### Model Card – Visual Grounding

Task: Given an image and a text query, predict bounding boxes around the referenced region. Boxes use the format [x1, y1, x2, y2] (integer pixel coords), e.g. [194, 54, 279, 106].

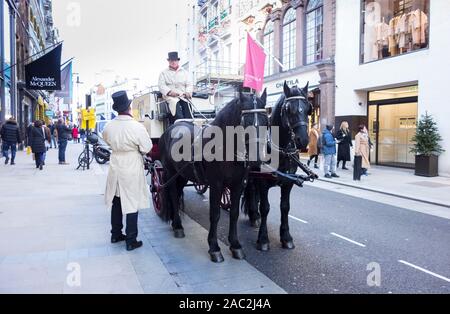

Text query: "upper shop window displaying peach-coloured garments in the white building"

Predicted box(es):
[361, 0, 430, 63]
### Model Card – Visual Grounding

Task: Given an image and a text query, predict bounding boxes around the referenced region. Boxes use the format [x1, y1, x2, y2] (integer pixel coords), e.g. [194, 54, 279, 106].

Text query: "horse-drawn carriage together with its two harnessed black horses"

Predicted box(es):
[132, 84, 317, 262]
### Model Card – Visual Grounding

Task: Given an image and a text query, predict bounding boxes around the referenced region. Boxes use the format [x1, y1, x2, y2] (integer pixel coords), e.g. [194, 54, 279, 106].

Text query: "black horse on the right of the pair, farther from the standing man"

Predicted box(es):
[243, 82, 313, 251]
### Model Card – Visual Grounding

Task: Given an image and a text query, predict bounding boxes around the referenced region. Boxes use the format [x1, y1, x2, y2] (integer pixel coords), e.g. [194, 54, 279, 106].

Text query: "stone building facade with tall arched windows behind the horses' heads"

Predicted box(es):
[251, 0, 336, 125]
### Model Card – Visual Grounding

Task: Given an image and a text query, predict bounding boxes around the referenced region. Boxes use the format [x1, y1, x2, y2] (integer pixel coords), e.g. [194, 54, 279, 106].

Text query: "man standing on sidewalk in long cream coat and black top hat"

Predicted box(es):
[103, 91, 152, 251]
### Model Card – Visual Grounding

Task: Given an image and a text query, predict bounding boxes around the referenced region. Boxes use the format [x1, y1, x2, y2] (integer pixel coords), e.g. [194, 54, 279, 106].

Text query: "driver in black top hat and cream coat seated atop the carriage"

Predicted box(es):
[159, 52, 192, 124]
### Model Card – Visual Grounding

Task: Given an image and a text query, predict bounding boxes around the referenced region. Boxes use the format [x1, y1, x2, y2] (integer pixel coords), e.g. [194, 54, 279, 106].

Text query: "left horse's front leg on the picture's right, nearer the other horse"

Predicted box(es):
[228, 183, 245, 260]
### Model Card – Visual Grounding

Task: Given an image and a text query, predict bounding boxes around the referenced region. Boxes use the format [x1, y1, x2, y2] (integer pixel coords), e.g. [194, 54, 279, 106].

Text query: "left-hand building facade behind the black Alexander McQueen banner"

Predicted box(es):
[0, 0, 57, 142]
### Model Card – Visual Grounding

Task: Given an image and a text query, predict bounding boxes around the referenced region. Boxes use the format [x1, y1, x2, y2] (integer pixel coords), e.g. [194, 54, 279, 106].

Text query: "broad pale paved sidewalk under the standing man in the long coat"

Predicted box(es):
[0, 144, 285, 294]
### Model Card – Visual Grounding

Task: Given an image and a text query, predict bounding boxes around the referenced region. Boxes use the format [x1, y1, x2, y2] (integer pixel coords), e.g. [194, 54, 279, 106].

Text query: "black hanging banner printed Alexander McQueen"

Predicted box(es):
[25, 44, 62, 91]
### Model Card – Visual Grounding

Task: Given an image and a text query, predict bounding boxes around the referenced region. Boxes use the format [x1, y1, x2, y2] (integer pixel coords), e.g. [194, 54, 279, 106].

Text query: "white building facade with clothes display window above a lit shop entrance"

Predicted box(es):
[336, 0, 450, 176]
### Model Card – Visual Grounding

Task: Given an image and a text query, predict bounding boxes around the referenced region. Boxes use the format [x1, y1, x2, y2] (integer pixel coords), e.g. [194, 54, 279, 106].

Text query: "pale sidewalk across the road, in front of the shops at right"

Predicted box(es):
[303, 159, 450, 208]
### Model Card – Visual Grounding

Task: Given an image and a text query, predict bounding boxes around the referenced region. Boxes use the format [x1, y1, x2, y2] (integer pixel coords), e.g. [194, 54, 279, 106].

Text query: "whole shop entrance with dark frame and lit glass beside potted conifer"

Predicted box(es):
[369, 86, 418, 168]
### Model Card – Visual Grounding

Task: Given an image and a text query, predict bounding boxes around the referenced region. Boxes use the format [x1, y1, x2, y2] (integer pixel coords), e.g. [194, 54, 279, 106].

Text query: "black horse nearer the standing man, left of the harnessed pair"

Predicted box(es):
[159, 91, 269, 263]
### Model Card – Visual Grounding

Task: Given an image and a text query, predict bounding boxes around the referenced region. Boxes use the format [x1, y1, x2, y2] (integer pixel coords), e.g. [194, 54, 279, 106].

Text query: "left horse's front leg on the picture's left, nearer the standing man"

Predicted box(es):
[208, 184, 225, 263]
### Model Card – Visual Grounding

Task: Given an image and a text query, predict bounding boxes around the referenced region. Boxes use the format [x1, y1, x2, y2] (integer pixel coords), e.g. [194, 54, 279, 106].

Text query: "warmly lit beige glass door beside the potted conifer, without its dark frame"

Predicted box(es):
[375, 103, 418, 167]
